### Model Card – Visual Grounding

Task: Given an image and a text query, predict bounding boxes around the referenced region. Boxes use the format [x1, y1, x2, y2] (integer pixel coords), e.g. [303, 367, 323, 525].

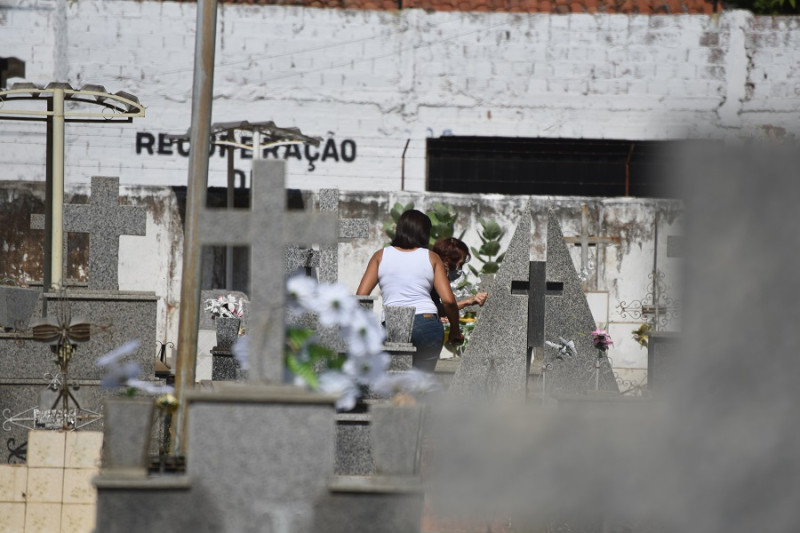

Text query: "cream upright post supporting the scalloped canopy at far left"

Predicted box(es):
[49, 89, 64, 290]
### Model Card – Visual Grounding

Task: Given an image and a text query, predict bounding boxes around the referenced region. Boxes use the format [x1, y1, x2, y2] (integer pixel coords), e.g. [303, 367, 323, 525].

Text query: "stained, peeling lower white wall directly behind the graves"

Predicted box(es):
[0, 183, 683, 386]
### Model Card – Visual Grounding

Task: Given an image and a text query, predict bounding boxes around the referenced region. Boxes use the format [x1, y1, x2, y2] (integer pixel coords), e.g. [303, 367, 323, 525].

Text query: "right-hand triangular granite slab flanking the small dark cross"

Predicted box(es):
[544, 211, 619, 394]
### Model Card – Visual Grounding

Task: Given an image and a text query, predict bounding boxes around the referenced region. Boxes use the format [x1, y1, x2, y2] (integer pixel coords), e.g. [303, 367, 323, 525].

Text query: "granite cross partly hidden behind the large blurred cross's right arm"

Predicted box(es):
[287, 189, 369, 283]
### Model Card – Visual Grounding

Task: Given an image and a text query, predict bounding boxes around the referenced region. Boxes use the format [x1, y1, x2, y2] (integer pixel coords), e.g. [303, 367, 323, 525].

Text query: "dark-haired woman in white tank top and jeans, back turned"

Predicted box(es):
[356, 209, 464, 372]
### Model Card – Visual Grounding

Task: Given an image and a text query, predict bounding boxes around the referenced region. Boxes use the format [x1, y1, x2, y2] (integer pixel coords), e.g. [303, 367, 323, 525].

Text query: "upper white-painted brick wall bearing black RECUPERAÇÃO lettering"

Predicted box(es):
[0, 0, 800, 191]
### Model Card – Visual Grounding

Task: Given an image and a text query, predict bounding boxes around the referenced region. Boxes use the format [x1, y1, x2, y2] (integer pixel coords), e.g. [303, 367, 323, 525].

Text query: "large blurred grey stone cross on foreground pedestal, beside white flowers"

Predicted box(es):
[197, 160, 339, 383]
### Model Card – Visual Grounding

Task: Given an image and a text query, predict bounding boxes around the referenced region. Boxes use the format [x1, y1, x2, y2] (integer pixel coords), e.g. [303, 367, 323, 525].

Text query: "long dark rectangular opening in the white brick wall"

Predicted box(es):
[427, 136, 678, 198]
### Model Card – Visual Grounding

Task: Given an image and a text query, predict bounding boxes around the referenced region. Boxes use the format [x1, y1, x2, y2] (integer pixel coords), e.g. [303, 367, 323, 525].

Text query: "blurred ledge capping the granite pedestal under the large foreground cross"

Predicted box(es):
[186, 381, 337, 406]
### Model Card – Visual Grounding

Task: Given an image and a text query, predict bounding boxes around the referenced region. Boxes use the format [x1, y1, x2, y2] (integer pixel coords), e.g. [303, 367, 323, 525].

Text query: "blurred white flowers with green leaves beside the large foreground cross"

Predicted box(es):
[233, 275, 436, 411]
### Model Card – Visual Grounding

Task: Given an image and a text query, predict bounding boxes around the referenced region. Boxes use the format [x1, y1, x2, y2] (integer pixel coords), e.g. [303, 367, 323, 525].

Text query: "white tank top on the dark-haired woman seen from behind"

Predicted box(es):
[378, 246, 436, 314]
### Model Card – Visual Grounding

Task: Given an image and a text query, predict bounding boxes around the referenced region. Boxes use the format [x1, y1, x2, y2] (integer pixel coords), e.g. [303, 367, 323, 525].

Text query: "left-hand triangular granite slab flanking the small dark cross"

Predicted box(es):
[450, 204, 531, 401]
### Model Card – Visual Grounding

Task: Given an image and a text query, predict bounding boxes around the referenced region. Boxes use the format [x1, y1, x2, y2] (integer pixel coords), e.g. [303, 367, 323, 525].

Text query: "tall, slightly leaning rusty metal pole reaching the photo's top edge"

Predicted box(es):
[174, 0, 217, 453]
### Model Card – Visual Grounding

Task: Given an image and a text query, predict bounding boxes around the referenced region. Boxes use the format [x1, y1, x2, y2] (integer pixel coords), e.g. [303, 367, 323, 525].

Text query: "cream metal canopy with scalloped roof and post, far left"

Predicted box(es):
[0, 82, 145, 290]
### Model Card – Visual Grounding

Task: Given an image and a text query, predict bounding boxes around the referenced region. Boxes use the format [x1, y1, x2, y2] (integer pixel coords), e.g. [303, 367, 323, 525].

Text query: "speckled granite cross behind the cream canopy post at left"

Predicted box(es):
[31, 176, 147, 291]
